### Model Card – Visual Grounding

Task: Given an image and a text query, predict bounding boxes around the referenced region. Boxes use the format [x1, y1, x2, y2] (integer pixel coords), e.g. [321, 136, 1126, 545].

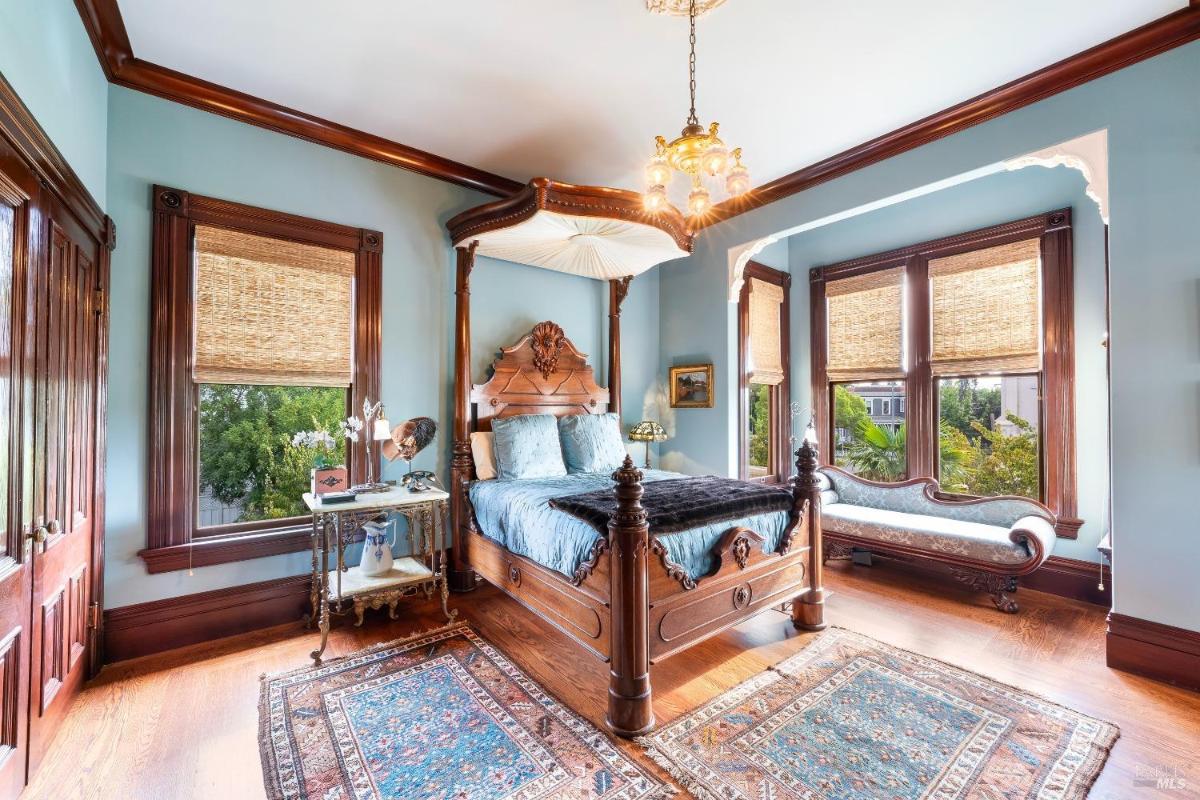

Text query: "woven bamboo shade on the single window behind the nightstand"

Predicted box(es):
[192, 225, 355, 386]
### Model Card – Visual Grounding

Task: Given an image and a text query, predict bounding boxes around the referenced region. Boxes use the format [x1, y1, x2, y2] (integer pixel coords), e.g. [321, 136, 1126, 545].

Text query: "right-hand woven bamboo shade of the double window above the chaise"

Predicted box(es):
[929, 239, 1042, 375]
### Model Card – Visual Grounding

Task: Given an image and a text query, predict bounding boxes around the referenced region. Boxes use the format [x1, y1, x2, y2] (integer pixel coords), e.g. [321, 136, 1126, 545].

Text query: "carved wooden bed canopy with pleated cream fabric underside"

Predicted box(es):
[446, 178, 691, 281]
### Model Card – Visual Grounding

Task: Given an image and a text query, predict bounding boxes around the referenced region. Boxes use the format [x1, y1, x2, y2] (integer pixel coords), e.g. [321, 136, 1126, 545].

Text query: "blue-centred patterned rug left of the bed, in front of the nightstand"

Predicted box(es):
[259, 625, 674, 800]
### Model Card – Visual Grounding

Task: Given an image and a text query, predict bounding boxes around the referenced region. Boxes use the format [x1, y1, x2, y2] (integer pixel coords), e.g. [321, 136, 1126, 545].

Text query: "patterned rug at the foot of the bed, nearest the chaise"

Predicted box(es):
[641, 628, 1120, 800]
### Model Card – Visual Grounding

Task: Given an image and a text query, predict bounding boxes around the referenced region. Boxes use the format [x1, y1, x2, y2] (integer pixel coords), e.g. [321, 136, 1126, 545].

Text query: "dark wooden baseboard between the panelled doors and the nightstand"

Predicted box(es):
[104, 575, 311, 663]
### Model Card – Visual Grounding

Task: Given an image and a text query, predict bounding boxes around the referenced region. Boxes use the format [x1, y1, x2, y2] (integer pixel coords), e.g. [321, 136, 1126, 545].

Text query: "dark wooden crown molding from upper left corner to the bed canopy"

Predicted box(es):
[76, 0, 524, 197]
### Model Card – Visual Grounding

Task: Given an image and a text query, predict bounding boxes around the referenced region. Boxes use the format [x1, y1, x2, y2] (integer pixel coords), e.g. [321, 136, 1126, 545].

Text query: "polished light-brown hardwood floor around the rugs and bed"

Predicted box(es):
[23, 563, 1200, 800]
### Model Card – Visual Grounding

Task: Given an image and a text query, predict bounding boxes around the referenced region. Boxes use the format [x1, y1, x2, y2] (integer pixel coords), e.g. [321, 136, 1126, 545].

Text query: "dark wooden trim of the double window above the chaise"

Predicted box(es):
[809, 209, 1084, 539]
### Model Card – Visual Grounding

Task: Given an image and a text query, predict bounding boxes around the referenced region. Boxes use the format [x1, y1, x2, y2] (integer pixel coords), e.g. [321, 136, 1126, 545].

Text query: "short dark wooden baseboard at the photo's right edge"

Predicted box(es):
[1105, 613, 1200, 691]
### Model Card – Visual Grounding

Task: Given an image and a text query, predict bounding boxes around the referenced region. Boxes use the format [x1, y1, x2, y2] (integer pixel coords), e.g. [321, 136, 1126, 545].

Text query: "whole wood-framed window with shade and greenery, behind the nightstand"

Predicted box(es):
[142, 187, 383, 572]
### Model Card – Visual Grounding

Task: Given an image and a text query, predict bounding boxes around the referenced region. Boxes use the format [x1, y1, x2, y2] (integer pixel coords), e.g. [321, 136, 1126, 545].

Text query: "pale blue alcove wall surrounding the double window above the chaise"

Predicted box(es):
[784, 167, 1109, 561]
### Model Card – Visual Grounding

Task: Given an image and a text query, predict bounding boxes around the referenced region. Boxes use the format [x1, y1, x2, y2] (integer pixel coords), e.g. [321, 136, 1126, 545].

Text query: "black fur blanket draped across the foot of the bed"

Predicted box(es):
[550, 476, 792, 535]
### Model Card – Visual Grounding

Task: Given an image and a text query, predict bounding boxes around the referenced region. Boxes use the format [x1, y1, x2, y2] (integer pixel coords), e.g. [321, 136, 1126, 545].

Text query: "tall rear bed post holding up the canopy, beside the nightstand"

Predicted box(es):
[449, 241, 479, 591]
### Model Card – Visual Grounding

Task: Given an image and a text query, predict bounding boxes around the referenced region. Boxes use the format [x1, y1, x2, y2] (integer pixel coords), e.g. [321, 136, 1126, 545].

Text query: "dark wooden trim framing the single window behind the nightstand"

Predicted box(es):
[138, 186, 383, 572]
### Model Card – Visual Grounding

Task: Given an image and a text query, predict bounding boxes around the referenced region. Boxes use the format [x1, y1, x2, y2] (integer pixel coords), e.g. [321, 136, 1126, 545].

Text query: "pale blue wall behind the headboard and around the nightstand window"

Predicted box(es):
[104, 86, 659, 607]
